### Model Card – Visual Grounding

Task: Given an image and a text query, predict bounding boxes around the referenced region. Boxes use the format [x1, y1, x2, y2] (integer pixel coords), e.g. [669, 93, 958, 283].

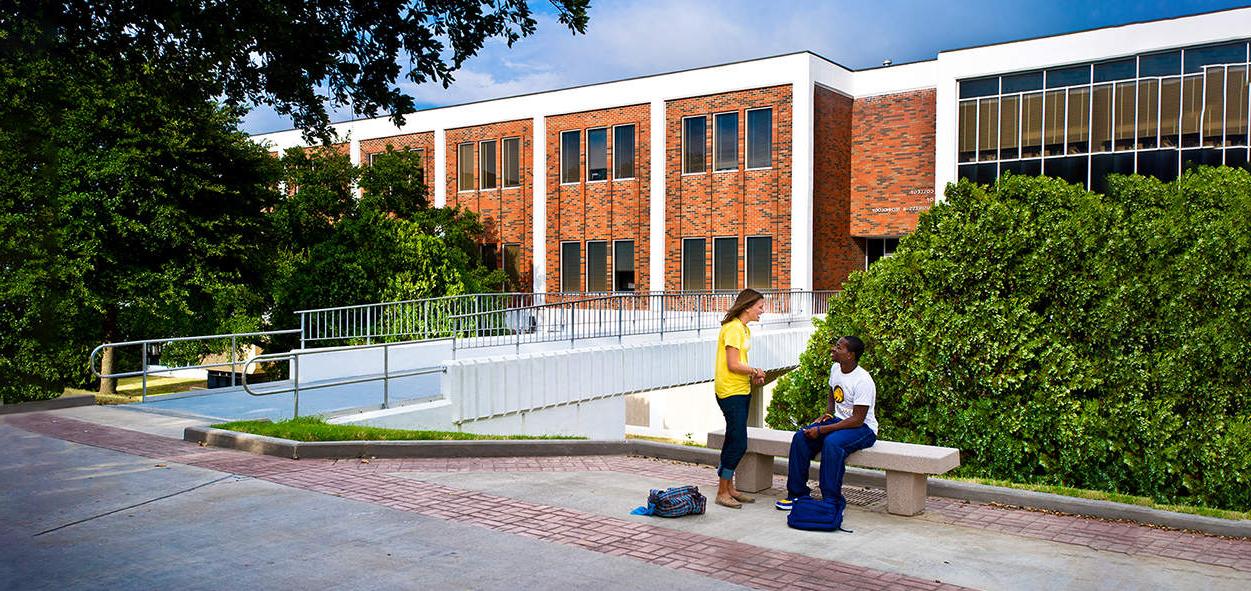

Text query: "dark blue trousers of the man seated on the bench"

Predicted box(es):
[786, 418, 877, 498]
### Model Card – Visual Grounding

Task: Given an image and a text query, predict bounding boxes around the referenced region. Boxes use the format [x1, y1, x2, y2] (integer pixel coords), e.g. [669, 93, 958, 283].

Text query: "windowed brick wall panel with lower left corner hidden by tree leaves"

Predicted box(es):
[444, 119, 534, 290]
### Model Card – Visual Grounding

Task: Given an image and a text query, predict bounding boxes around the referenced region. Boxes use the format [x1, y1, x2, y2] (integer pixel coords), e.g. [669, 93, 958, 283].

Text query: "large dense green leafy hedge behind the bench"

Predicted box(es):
[768, 168, 1251, 511]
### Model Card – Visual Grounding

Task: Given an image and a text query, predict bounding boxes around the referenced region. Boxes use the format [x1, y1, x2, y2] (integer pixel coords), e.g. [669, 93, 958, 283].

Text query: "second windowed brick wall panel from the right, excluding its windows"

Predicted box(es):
[547, 104, 652, 292]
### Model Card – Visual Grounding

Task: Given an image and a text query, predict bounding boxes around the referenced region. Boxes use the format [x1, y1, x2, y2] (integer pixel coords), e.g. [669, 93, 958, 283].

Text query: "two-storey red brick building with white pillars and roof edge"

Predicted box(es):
[255, 9, 1251, 292]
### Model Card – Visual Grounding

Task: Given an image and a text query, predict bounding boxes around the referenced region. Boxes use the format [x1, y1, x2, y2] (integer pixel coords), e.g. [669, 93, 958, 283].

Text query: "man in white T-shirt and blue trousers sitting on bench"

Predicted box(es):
[774, 337, 877, 511]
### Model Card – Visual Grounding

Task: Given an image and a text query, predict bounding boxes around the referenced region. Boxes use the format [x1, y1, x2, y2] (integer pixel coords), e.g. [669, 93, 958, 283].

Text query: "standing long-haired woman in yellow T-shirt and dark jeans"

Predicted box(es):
[714, 289, 764, 508]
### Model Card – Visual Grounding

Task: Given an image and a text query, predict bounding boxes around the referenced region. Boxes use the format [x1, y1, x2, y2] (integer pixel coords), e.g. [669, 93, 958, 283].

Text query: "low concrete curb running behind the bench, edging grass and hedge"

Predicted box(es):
[183, 427, 1251, 537]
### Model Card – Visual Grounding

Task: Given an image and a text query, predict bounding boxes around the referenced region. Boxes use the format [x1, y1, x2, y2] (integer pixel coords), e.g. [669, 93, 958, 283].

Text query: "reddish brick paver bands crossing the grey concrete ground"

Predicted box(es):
[4, 413, 1251, 590]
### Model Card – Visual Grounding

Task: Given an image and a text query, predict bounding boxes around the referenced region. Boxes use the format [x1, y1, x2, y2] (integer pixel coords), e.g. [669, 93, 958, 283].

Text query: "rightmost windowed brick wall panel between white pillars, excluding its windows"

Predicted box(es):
[664, 85, 792, 289]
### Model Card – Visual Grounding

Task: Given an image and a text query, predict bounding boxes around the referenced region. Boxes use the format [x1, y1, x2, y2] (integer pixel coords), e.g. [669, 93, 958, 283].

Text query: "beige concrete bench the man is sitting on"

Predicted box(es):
[708, 427, 960, 516]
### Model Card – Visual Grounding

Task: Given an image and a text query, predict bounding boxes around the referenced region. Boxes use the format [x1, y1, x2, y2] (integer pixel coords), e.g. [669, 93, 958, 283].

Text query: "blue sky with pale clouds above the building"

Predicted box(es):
[243, 0, 1247, 133]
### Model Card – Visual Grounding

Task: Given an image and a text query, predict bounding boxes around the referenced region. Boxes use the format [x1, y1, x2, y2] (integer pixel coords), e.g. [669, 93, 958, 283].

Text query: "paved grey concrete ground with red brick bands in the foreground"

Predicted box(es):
[0, 407, 1251, 590]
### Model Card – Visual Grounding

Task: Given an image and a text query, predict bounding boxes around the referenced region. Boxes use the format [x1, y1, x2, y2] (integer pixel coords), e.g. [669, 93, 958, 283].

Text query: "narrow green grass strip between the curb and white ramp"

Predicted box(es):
[213, 417, 584, 441]
